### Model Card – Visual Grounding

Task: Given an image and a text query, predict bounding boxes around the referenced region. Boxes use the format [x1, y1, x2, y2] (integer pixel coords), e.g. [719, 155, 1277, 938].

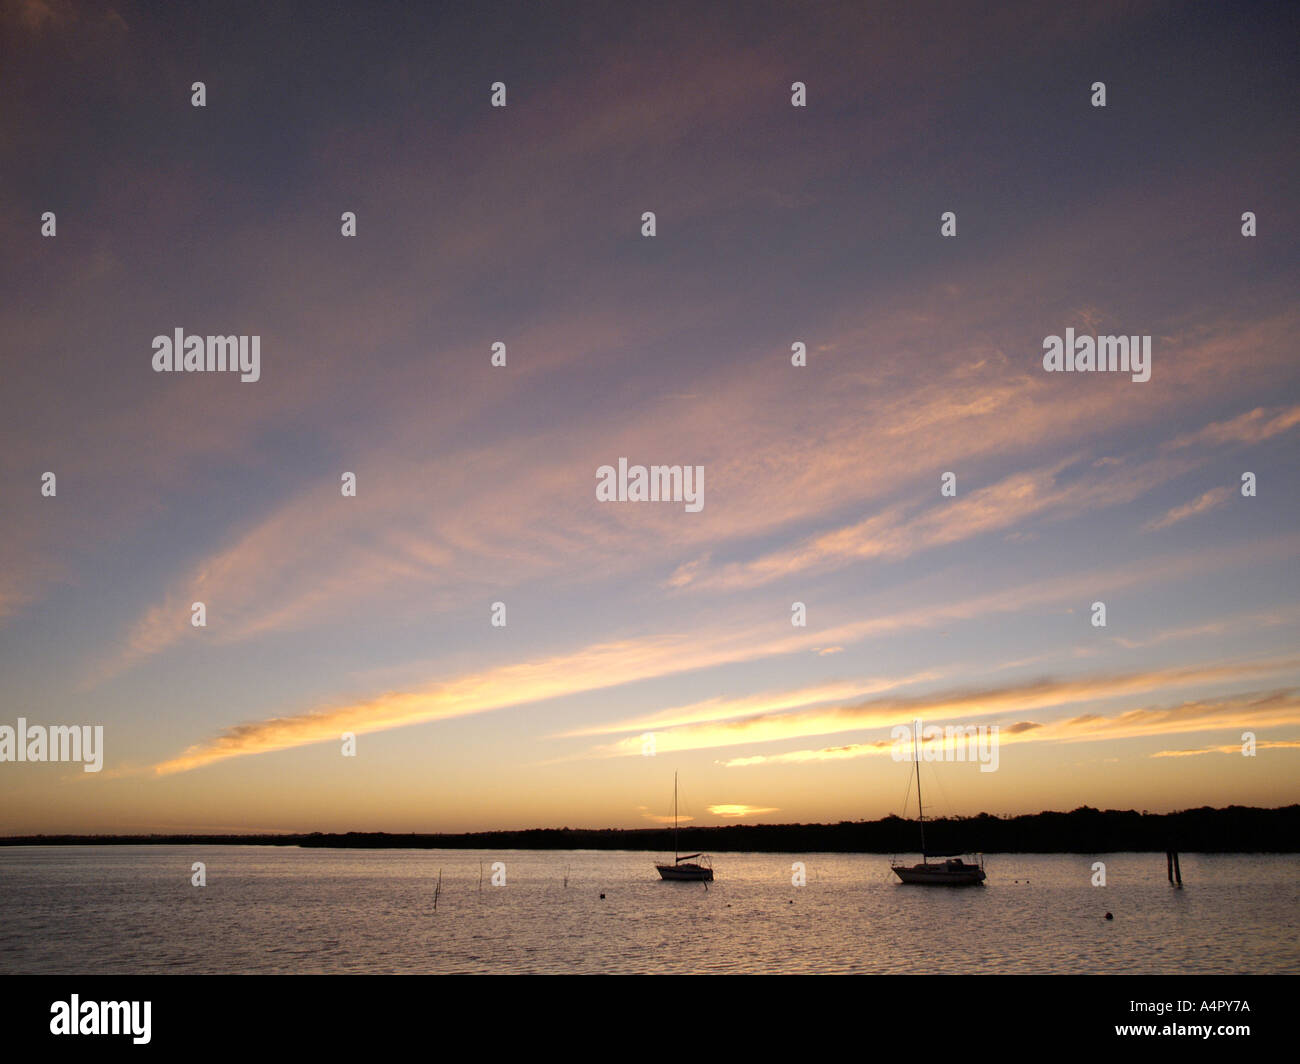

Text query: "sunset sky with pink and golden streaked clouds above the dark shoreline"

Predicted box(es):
[0, 0, 1300, 834]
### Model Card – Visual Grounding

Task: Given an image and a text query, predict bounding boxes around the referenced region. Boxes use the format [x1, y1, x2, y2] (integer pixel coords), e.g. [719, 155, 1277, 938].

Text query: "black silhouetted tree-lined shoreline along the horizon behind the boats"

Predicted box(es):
[0, 805, 1300, 853]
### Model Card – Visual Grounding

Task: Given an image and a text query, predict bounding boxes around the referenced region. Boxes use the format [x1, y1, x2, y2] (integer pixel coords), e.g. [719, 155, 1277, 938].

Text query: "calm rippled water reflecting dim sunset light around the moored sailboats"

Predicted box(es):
[0, 845, 1300, 974]
